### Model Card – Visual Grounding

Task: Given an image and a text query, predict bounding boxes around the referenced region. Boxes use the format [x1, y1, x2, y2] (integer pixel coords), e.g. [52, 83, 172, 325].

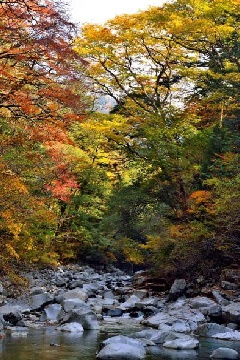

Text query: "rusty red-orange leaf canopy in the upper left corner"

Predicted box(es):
[0, 0, 86, 118]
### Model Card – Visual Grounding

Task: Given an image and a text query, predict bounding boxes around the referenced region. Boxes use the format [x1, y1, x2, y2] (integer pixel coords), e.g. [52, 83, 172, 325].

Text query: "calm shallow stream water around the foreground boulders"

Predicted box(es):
[0, 327, 240, 360]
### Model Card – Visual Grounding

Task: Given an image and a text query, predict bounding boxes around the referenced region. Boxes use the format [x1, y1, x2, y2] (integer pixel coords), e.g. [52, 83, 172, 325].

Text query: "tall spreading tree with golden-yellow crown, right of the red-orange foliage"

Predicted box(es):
[75, 0, 239, 269]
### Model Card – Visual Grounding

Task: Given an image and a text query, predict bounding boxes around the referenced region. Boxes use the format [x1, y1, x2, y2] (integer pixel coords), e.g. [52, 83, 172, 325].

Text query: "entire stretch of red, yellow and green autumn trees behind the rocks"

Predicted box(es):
[0, 0, 240, 284]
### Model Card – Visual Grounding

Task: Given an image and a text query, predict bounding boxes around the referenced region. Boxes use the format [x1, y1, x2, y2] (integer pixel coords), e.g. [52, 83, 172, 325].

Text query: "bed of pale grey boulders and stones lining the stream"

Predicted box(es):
[0, 265, 240, 360]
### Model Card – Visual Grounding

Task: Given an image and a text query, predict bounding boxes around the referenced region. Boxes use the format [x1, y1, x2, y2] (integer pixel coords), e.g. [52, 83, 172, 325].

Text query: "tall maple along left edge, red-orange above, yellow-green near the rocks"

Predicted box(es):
[0, 0, 87, 272]
